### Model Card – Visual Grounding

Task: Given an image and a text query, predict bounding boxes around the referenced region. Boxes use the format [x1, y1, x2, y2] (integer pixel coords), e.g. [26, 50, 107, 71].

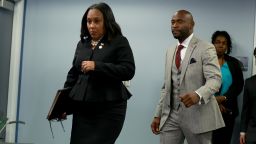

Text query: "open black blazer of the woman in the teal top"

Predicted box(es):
[220, 55, 244, 118]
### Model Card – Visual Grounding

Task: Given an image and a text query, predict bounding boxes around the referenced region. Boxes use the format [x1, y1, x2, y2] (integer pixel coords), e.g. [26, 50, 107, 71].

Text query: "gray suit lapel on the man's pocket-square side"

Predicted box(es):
[180, 37, 198, 82]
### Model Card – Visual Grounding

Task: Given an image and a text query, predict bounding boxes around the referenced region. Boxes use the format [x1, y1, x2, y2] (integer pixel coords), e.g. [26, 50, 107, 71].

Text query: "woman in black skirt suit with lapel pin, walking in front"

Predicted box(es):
[64, 3, 135, 144]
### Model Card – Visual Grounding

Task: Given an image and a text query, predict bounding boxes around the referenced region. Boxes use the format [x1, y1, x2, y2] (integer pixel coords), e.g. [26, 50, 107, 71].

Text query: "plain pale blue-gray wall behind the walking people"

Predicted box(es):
[18, 0, 255, 144]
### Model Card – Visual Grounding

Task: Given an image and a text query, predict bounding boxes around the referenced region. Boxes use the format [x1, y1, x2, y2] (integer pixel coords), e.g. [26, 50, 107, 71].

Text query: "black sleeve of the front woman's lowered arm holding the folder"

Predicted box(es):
[64, 44, 80, 88]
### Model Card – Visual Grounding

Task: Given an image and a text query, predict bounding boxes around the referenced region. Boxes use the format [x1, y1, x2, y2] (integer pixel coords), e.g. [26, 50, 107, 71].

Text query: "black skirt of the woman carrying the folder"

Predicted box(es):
[70, 101, 127, 144]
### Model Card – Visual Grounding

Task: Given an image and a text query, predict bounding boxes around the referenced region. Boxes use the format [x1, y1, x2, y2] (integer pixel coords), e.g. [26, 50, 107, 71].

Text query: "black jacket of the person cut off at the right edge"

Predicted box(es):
[240, 75, 256, 141]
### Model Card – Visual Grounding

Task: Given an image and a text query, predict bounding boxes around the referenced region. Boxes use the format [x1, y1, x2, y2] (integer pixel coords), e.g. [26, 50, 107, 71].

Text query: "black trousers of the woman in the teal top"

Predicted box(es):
[212, 114, 235, 144]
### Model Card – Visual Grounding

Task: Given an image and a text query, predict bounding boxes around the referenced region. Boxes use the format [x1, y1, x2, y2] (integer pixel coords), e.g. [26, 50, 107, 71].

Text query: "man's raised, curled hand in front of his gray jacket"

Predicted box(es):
[180, 92, 200, 107]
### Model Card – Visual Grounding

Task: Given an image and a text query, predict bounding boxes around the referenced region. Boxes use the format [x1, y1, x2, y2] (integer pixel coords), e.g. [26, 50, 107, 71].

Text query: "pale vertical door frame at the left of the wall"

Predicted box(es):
[5, 0, 26, 143]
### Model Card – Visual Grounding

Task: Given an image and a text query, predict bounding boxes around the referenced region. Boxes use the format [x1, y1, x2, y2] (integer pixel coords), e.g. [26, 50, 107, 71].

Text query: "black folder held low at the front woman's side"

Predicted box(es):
[47, 87, 73, 121]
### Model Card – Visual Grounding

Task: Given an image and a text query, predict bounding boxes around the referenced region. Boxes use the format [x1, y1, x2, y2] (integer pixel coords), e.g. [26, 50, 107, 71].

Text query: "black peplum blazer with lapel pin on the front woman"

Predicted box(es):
[64, 36, 135, 102]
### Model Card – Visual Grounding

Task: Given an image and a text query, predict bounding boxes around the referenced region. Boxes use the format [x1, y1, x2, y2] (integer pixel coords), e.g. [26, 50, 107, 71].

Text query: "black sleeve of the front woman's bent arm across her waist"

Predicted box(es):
[95, 36, 135, 81]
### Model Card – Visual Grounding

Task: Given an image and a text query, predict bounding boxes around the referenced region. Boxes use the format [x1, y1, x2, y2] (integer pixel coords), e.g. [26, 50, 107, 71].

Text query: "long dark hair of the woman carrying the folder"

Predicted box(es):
[80, 3, 122, 42]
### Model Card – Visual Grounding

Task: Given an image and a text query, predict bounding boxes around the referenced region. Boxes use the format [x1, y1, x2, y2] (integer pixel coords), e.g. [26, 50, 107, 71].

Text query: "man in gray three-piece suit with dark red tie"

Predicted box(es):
[151, 10, 225, 144]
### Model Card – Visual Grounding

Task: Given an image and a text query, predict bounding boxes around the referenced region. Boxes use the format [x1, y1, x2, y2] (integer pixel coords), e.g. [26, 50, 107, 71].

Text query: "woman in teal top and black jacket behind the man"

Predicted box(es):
[212, 31, 244, 144]
